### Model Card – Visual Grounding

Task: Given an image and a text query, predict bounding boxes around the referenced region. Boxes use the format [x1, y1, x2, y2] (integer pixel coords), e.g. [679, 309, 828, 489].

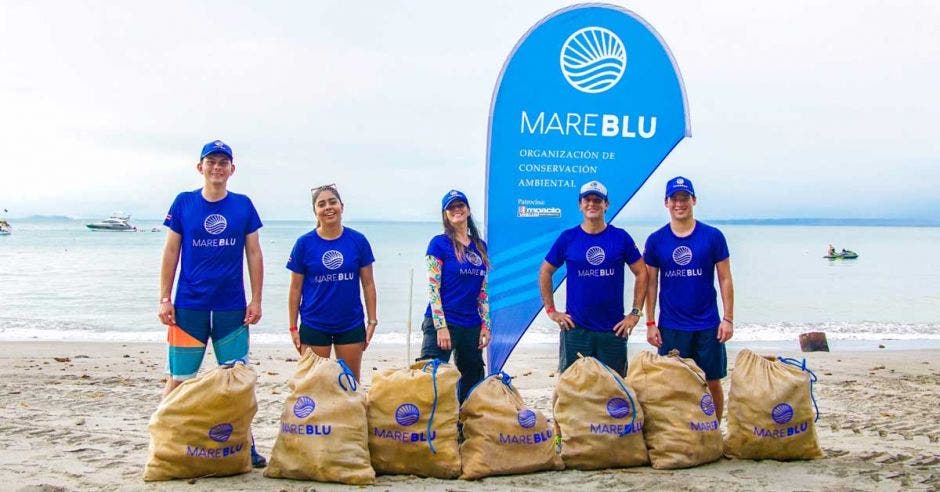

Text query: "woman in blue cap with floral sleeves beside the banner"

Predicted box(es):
[421, 190, 490, 403]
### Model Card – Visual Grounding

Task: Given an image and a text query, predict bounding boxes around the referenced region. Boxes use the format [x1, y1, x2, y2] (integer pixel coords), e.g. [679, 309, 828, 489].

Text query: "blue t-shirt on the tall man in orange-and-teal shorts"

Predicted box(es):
[163, 189, 261, 311]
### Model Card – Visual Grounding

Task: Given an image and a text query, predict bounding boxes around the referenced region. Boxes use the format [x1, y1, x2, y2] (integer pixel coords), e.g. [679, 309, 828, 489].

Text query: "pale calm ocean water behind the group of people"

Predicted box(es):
[0, 220, 940, 347]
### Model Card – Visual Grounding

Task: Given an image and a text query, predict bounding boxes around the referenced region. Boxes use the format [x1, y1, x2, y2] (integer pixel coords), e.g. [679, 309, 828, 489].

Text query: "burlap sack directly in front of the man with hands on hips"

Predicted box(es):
[552, 357, 650, 470]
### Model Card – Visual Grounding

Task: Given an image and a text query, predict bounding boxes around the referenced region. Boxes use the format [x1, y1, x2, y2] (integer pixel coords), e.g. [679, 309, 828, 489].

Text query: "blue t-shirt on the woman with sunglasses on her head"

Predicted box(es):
[287, 227, 375, 333]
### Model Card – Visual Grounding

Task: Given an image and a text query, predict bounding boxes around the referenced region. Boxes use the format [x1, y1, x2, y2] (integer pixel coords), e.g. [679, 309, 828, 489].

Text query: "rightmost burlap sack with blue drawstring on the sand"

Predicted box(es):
[724, 349, 823, 460]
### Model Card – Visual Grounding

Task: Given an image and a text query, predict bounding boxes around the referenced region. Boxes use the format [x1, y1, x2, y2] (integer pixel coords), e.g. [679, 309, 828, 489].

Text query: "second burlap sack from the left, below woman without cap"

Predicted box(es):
[264, 350, 375, 485]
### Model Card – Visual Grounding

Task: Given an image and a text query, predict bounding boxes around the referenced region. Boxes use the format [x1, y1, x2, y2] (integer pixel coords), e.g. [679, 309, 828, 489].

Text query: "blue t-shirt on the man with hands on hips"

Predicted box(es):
[545, 225, 640, 331]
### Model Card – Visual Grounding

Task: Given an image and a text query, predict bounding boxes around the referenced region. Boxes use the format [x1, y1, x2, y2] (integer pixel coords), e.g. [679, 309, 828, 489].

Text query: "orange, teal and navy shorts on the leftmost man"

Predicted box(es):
[167, 309, 248, 381]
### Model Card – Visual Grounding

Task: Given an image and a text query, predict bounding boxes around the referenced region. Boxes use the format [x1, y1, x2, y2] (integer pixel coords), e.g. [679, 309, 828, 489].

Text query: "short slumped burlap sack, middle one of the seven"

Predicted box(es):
[460, 373, 564, 480]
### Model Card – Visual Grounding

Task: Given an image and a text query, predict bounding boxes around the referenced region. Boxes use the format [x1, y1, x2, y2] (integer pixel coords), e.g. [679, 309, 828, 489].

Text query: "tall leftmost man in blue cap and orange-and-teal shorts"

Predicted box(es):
[157, 140, 265, 467]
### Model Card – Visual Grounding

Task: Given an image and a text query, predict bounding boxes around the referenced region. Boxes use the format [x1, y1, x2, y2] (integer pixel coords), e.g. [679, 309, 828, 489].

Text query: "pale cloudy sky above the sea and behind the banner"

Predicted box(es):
[0, 0, 940, 220]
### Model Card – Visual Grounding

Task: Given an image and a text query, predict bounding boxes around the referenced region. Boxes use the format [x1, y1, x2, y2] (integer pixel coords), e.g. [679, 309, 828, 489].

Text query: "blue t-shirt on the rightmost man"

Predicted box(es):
[643, 221, 730, 331]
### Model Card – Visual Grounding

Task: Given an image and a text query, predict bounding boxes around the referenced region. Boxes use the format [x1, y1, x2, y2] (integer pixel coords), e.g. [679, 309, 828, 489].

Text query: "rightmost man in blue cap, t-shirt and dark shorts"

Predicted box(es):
[643, 176, 734, 422]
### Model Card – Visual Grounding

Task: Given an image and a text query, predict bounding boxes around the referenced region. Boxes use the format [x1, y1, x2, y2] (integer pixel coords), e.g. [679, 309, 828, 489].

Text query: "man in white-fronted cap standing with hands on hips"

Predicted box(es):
[539, 181, 647, 376]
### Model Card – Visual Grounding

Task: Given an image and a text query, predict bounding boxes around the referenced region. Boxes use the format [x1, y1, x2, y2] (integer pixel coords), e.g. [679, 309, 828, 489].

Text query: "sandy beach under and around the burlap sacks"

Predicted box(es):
[0, 342, 940, 491]
